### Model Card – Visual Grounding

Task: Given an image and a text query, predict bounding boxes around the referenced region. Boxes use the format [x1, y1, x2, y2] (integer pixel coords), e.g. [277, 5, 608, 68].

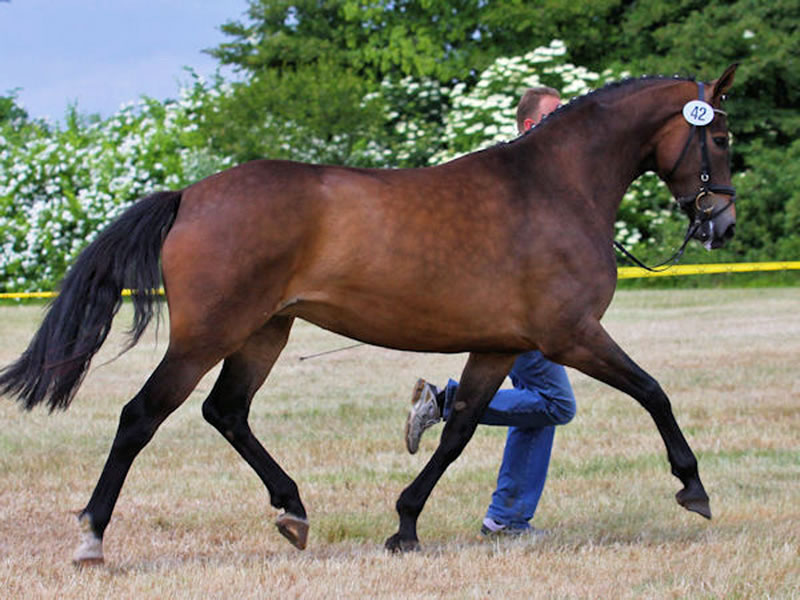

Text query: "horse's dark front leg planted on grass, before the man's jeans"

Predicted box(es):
[386, 354, 516, 552]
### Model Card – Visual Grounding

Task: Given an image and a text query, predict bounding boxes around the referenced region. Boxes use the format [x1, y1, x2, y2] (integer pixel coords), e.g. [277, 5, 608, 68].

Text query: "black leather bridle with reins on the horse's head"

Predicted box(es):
[614, 81, 736, 272]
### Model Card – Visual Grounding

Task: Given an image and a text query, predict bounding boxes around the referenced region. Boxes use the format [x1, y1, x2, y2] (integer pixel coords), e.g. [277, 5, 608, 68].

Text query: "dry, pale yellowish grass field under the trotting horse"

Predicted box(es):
[0, 288, 800, 599]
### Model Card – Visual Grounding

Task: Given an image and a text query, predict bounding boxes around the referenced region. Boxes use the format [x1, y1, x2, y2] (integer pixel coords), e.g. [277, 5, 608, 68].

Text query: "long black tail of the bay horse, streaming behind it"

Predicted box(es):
[0, 192, 181, 411]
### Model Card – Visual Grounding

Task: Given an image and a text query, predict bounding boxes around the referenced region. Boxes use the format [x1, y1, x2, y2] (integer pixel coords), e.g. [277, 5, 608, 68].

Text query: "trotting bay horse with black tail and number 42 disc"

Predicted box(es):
[0, 65, 736, 564]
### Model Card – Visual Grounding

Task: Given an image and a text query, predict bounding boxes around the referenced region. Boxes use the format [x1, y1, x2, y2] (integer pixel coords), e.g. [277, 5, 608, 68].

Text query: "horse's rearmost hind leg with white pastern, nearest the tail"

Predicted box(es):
[73, 350, 214, 564]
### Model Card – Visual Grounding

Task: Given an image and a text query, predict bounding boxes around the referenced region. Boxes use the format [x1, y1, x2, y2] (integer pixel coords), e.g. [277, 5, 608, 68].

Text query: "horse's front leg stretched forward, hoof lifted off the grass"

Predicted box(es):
[549, 321, 711, 519]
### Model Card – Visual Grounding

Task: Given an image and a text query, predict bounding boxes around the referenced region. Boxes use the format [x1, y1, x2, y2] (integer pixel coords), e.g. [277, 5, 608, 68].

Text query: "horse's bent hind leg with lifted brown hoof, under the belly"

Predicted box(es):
[203, 317, 308, 550]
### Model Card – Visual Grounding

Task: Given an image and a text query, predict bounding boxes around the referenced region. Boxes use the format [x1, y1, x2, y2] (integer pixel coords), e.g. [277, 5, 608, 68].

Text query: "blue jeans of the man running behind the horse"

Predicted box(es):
[443, 352, 576, 529]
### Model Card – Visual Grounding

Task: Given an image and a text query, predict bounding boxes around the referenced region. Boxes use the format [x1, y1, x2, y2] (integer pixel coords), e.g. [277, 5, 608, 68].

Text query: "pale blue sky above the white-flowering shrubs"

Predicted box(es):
[0, 0, 247, 121]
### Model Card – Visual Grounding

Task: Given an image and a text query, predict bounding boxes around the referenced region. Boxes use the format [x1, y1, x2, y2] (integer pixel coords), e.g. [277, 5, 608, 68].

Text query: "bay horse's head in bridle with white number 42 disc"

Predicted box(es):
[656, 64, 737, 249]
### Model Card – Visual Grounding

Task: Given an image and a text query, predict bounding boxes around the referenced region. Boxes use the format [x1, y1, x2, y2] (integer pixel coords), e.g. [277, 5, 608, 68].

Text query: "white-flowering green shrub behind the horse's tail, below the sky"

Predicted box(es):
[0, 81, 227, 291]
